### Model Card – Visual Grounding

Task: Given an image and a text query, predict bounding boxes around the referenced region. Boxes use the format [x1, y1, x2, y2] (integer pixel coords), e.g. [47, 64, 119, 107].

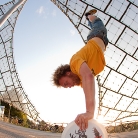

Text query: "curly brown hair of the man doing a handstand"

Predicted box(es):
[52, 64, 71, 87]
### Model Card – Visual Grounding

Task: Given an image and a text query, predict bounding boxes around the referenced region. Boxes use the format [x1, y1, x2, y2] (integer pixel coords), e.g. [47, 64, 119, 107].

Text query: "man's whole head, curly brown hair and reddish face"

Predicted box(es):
[52, 64, 80, 88]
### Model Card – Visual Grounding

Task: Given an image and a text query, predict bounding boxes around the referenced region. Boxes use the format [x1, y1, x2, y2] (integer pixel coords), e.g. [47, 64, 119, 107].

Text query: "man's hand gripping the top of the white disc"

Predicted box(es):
[75, 112, 93, 130]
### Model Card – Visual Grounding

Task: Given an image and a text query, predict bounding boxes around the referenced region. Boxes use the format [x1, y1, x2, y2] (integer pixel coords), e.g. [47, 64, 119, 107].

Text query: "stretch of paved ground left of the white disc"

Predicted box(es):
[0, 121, 61, 138]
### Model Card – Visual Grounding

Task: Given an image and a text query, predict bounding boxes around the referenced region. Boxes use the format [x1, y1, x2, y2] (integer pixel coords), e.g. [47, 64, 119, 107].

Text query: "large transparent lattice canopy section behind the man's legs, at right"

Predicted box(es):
[51, 0, 138, 122]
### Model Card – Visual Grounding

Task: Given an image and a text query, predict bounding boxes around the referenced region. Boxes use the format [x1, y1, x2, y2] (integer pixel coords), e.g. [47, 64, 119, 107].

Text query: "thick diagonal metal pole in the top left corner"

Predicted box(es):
[0, 0, 26, 27]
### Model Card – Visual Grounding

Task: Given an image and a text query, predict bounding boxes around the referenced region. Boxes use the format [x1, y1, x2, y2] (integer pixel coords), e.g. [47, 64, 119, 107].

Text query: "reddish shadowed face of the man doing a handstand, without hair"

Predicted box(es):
[59, 72, 80, 88]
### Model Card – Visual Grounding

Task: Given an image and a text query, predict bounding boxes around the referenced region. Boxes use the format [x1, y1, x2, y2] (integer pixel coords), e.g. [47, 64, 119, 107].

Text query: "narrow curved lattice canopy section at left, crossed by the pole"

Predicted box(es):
[0, 0, 39, 120]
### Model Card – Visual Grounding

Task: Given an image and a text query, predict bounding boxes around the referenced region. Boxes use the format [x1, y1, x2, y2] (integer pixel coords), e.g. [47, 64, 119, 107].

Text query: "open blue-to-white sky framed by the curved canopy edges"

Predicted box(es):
[0, 0, 100, 123]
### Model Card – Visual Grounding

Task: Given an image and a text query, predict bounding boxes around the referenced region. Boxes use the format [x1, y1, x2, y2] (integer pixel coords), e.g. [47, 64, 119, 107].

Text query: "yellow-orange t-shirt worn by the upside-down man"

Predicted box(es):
[70, 40, 105, 79]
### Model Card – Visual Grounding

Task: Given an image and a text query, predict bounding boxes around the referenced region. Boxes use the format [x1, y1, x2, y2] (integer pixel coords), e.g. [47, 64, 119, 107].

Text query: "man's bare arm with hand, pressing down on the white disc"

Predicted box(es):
[75, 62, 95, 130]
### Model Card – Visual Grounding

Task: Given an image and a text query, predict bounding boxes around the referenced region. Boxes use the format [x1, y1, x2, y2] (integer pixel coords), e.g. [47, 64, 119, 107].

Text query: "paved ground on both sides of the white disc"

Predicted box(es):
[0, 121, 138, 138]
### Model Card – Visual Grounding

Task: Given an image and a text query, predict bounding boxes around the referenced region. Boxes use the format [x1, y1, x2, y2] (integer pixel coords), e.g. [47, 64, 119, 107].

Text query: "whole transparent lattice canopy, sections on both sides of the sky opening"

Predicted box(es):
[0, 0, 138, 122]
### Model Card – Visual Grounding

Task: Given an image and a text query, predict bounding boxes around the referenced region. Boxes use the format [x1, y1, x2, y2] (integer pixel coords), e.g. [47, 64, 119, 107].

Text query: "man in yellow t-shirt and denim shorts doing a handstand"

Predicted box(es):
[52, 9, 108, 130]
